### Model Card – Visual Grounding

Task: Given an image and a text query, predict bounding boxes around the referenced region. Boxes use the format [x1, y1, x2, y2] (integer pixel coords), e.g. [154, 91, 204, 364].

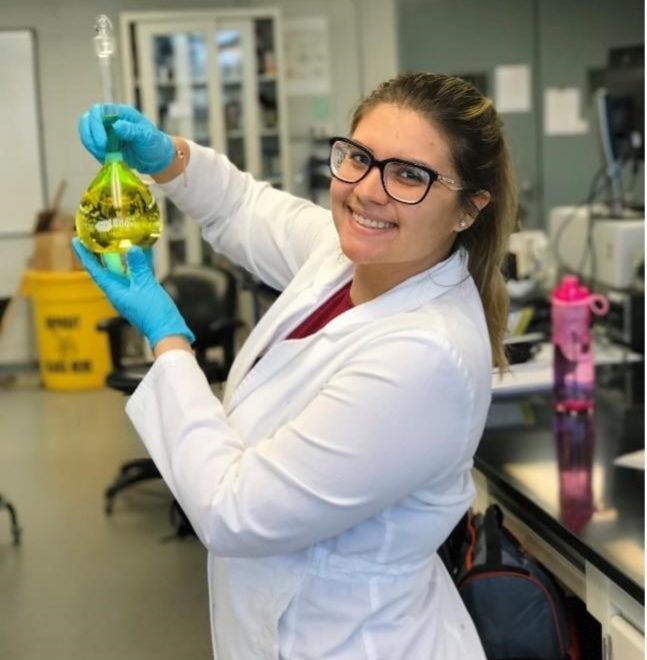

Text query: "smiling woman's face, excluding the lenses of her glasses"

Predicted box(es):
[330, 103, 471, 286]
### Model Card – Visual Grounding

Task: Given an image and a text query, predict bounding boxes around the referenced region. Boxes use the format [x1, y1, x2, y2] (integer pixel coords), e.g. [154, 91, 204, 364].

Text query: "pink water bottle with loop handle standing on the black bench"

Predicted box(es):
[551, 275, 609, 410]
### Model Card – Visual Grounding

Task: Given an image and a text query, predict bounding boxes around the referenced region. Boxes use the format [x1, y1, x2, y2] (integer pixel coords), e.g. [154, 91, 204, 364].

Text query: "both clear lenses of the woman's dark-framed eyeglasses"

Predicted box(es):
[330, 140, 430, 204]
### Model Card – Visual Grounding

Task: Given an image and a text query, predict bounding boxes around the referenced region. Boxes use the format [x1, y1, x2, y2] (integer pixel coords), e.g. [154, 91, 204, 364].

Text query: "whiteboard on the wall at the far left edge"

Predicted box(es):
[0, 30, 44, 241]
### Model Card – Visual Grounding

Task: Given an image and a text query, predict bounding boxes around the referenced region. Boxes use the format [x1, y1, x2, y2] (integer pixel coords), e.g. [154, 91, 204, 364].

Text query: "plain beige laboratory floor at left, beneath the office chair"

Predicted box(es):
[0, 374, 211, 660]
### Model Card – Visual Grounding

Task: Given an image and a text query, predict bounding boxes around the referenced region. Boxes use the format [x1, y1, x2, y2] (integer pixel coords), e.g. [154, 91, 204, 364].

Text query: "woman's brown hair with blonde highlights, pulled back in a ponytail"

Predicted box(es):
[351, 73, 517, 371]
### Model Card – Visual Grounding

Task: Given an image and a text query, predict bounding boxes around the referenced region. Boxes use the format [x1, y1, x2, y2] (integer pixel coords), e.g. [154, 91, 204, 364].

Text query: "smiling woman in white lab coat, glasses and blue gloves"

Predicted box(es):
[76, 74, 515, 660]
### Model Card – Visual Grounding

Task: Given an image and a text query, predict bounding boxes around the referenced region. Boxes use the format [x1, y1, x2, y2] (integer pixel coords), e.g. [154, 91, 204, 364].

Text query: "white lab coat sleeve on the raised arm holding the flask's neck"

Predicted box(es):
[153, 142, 334, 291]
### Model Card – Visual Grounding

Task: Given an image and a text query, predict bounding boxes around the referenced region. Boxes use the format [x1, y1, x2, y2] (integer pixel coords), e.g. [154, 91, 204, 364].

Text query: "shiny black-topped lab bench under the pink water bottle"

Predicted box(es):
[474, 363, 645, 660]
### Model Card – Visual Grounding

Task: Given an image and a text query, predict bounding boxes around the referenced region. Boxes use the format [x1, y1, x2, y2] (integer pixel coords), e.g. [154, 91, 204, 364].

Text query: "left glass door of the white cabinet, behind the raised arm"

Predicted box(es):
[136, 21, 214, 274]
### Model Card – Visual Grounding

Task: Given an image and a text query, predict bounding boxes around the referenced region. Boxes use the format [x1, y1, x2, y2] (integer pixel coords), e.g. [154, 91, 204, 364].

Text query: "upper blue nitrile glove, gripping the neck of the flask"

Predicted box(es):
[79, 103, 175, 174]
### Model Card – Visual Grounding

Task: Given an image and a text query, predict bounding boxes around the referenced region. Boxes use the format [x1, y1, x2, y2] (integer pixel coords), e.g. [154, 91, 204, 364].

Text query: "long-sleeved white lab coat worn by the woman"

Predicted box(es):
[127, 145, 491, 660]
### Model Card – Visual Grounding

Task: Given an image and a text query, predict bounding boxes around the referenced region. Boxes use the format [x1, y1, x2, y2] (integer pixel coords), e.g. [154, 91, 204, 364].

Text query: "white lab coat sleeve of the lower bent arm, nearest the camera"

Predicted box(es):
[127, 335, 481, 557]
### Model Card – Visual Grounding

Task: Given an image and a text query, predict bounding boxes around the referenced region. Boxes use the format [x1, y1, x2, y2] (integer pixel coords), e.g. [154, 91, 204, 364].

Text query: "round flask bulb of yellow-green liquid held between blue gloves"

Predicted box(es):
[76, 116, 162, 274]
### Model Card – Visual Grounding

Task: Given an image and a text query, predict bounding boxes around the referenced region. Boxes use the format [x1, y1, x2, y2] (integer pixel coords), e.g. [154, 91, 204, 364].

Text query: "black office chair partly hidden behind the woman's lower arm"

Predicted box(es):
[97, 265, 243, 536]
